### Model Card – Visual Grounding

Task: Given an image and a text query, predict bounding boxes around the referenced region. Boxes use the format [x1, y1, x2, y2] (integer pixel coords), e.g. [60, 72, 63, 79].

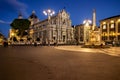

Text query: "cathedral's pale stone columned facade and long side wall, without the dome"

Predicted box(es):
[33, 9, 74, 44]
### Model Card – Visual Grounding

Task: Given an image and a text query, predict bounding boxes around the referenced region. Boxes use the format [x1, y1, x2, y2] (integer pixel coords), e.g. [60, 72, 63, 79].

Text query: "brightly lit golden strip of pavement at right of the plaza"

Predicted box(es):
[55, 46, 120, 57]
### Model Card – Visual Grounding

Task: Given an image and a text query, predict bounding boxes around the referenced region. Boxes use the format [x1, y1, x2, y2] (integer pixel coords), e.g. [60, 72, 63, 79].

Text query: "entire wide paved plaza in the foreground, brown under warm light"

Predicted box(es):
[0, 46, 120, 80]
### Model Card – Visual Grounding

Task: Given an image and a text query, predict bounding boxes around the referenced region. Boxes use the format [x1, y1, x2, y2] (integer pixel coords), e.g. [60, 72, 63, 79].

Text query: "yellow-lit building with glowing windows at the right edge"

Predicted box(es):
[100, 15, 120, 42]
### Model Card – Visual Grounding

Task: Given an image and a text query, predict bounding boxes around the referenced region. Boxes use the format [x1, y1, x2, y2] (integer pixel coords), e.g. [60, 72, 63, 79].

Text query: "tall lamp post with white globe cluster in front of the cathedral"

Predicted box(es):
[43, 9, 55, 46]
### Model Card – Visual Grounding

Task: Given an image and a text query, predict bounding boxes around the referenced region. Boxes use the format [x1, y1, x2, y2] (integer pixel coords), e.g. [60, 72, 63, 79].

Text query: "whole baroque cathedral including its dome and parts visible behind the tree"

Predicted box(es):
[9, 9, 74, 44]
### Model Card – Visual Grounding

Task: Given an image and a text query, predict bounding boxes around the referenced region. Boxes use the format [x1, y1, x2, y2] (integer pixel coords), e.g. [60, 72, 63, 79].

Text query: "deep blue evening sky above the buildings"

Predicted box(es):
[0, 0, 120, 37]
